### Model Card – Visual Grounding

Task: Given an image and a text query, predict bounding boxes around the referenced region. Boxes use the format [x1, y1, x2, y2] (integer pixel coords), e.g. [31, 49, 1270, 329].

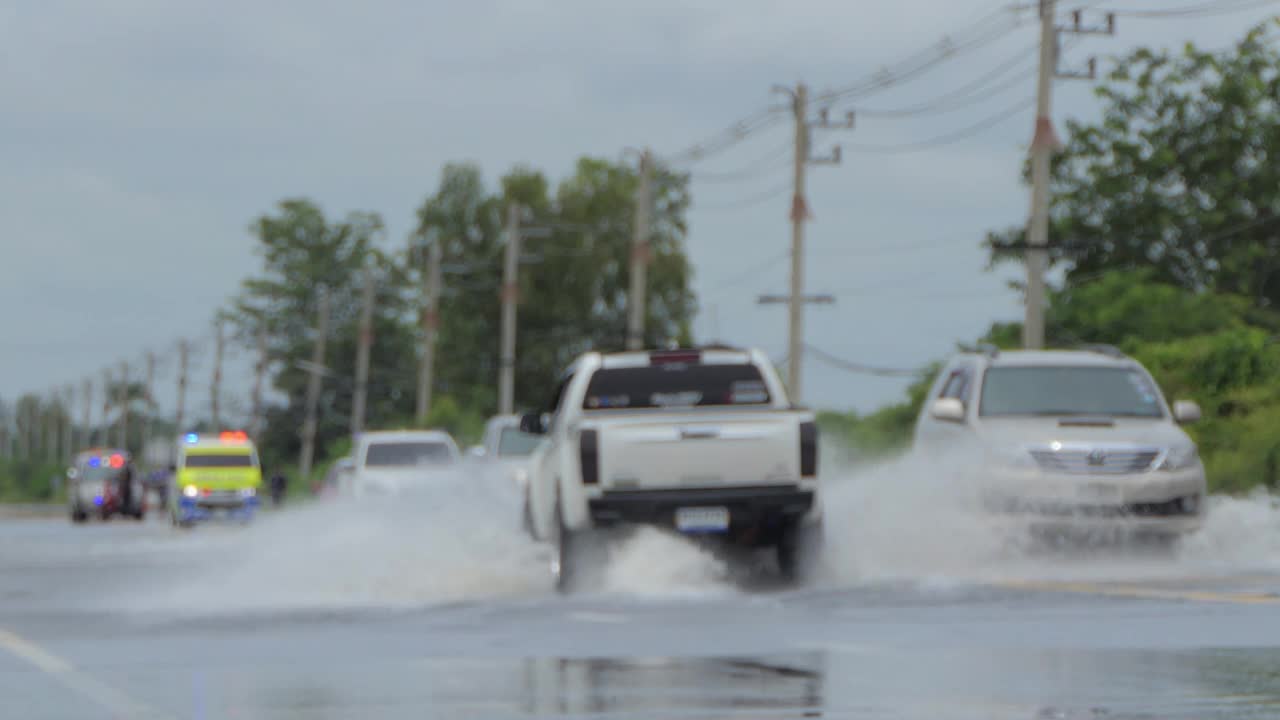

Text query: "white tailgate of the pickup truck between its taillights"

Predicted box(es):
[598, 411, 800, 491]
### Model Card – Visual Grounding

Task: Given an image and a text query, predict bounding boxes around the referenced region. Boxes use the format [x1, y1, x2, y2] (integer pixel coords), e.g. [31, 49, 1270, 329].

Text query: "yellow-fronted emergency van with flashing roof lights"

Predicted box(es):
[169, 432, 262, 527]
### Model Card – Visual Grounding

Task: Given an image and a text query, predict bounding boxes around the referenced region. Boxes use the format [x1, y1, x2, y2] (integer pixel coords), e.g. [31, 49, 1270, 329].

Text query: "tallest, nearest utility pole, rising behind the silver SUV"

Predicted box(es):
[1023, 0, 1115, 350]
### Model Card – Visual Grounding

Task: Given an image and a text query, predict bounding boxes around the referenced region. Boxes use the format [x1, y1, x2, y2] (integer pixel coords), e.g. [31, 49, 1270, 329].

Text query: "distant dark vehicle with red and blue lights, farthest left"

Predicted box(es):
[67, 447, 146, 523]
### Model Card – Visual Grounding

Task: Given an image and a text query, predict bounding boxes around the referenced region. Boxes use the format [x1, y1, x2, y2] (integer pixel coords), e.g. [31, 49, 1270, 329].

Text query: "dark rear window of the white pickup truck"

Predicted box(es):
[582, 364, 772, 410]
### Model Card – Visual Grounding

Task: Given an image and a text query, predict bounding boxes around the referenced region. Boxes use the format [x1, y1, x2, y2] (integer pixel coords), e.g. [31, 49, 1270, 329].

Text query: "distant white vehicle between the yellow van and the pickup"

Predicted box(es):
[351, 430, 461, 497]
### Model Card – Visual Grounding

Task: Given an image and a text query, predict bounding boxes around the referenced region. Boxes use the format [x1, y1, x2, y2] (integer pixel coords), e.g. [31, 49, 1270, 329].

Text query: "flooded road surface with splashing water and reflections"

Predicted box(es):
[0, 476, 1280, 720]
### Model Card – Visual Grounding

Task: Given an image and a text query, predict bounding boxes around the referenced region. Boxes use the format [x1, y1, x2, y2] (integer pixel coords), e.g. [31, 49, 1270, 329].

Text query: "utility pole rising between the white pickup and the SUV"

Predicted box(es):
[774, 82, 854, 402]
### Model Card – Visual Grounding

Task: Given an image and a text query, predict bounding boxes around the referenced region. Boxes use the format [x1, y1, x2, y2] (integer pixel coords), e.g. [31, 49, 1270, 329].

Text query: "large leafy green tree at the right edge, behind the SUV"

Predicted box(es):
[988, 20, 1280, 306]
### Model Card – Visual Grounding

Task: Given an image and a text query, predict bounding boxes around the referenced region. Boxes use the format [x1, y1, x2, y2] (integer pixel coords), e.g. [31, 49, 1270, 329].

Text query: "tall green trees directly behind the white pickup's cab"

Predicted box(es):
[410, 158, 696, 413]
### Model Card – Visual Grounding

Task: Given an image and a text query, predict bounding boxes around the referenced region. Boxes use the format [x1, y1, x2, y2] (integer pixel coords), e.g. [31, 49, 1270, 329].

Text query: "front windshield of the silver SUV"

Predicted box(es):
[978, 366, 1165, 418]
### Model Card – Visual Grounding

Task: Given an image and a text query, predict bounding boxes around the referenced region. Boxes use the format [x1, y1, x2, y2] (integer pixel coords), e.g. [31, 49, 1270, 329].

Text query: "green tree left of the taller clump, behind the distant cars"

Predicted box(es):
[227, 199, 416, 464]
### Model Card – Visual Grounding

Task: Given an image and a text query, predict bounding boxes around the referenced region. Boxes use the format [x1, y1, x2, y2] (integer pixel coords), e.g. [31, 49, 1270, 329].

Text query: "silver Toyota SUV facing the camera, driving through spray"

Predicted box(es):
[915, 346, 1206, 537]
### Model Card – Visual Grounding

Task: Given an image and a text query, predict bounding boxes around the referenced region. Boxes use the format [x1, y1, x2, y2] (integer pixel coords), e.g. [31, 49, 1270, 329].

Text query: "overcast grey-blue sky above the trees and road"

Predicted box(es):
[0, 0, 1267, 420]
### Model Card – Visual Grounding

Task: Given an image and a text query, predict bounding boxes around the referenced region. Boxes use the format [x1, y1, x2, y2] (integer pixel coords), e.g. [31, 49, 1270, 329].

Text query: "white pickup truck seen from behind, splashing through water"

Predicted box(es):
[521, 348, 822, 588]
